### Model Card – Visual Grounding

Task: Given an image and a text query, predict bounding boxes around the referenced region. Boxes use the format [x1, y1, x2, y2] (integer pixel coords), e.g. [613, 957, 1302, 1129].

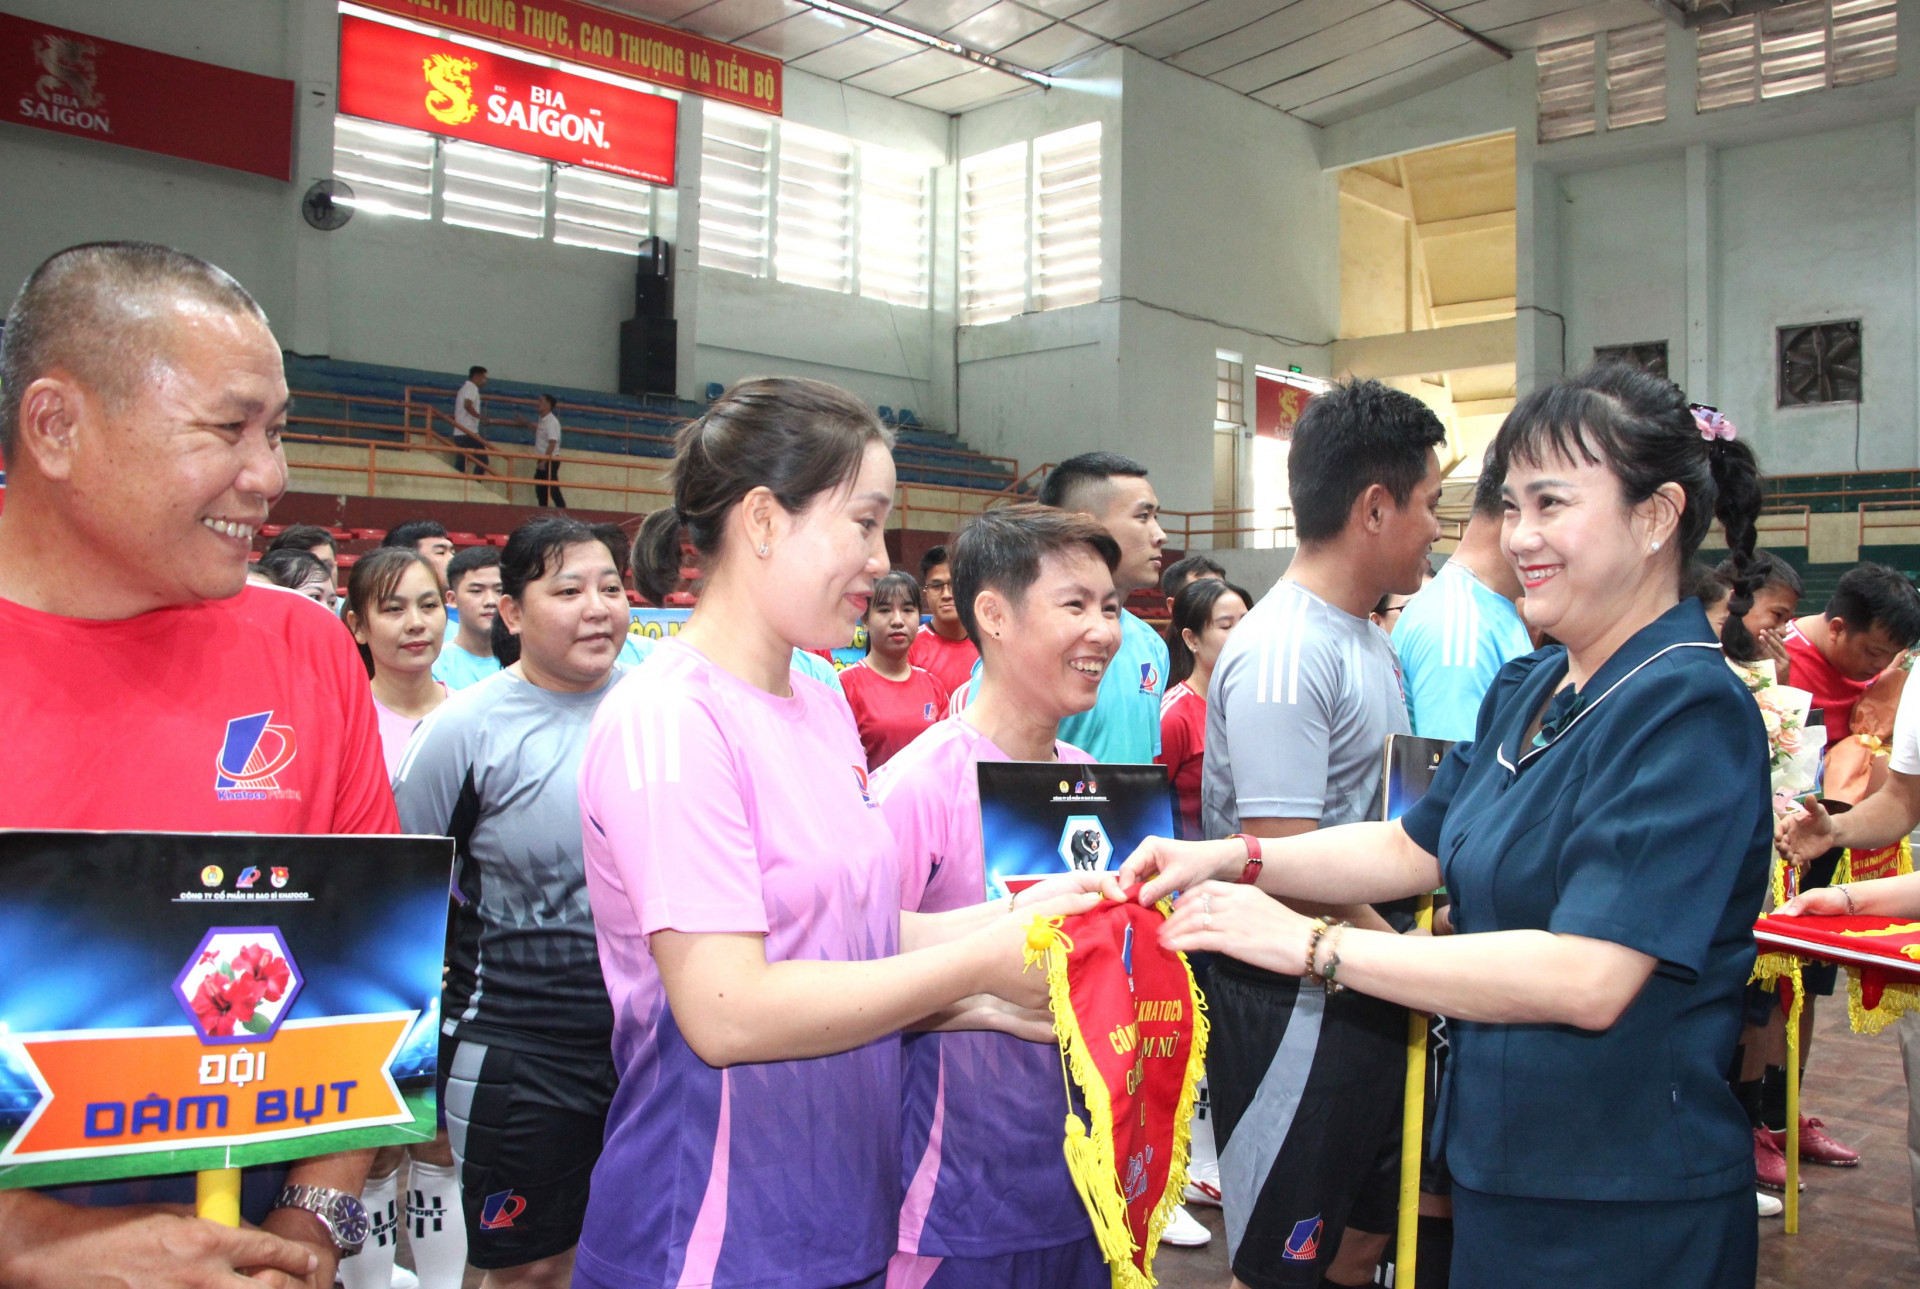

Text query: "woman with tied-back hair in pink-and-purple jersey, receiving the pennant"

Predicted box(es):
[574, 380, 1098, 1289]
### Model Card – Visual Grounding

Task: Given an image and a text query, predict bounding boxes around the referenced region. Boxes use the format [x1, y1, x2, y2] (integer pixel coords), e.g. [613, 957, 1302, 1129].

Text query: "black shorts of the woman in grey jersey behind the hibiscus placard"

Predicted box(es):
[440, 1039, 618, 1272]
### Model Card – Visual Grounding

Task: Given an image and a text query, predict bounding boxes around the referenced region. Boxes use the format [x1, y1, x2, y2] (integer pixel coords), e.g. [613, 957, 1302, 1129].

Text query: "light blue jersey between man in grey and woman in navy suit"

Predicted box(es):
[1394, 561, 1534, 740]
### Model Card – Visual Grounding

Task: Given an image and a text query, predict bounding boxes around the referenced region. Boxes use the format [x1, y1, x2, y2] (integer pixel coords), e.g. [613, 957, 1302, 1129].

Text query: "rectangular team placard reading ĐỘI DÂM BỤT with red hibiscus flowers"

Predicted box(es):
[0, 832, 451, 1187]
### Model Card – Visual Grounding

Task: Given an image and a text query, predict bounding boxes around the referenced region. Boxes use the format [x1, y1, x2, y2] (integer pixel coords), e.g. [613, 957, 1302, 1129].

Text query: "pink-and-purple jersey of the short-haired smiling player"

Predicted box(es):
[874, 717, 1092, 1258]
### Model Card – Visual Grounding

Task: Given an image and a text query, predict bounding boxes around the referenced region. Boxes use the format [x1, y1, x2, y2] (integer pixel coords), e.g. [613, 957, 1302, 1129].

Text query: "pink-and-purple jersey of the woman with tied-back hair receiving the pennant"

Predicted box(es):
[574, 640, 900, 1289]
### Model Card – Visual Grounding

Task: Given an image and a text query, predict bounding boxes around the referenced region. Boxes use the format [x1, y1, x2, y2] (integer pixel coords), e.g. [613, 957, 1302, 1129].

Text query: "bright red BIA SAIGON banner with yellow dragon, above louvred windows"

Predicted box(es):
[340, 15, 680, 184]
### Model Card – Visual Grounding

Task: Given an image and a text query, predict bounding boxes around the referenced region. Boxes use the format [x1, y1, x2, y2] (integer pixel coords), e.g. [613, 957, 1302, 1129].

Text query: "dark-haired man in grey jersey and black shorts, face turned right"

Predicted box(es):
[1200, 380, 1446, 1289]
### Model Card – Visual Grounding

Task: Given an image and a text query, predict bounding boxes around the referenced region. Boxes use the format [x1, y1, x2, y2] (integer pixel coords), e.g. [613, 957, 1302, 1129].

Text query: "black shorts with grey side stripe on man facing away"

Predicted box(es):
[1208, 959, 1407, 1289]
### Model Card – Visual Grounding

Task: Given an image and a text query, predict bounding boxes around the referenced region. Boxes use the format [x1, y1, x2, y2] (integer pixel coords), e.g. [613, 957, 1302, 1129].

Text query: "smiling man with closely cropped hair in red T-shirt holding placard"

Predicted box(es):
[0, 242, 399, 1289]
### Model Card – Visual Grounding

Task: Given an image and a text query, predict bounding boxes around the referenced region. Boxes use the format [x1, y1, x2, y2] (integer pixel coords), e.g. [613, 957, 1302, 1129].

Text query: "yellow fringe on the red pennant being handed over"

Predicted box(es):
[1025, 901, 1208, 1289]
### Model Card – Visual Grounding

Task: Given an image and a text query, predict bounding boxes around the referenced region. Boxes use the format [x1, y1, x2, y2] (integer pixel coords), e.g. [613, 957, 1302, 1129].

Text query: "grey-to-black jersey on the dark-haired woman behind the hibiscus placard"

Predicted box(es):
[394, 667, 624, 1049]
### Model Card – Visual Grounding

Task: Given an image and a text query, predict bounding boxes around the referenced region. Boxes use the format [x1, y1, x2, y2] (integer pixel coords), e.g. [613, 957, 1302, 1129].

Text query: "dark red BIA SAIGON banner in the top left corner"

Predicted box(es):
[0, 13, 294, 181]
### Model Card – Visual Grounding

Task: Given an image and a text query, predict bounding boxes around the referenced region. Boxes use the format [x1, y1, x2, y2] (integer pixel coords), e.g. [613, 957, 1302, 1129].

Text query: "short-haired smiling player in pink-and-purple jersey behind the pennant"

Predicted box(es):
[874, 505, 1119, 1289]
